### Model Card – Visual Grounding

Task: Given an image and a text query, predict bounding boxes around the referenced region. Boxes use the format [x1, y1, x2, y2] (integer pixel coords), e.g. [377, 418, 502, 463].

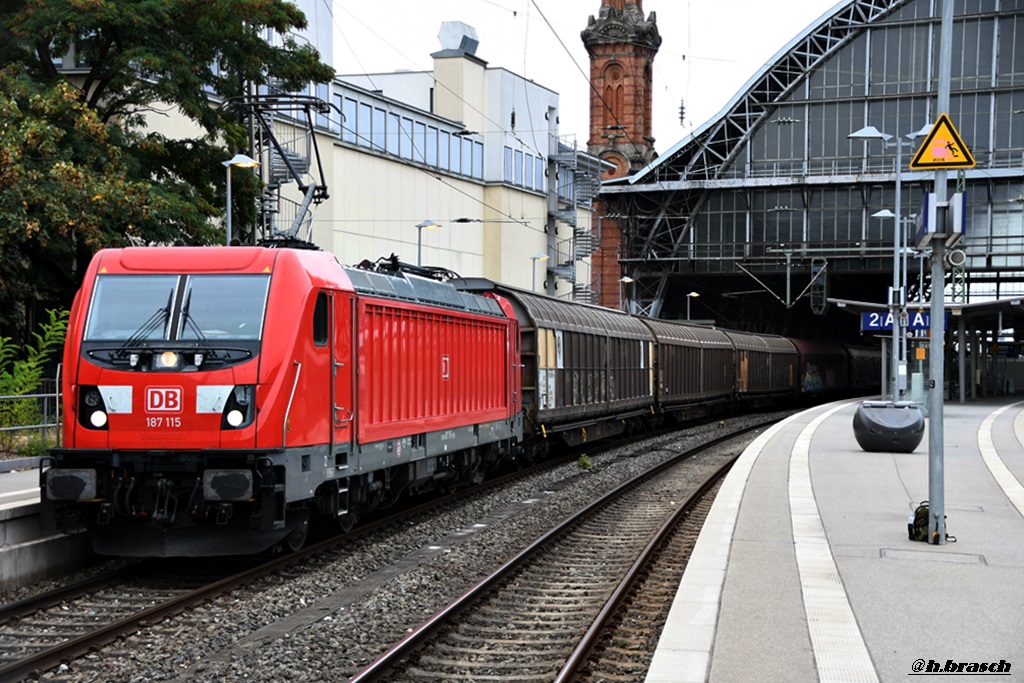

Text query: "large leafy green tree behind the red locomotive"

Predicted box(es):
[0, 0, 334, 339]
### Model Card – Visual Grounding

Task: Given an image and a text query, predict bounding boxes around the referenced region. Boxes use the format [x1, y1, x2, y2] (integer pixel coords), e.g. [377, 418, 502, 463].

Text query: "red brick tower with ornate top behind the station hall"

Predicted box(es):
[581, 0, 662, 308]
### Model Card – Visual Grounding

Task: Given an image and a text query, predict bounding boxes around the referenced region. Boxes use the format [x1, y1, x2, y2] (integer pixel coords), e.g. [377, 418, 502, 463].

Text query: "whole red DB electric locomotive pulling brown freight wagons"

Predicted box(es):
[41, 247, 522, 556]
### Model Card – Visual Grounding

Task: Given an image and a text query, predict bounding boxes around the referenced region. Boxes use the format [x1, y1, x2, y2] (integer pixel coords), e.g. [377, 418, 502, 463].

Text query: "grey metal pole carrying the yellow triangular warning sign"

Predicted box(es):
[928, 0, 953, 546]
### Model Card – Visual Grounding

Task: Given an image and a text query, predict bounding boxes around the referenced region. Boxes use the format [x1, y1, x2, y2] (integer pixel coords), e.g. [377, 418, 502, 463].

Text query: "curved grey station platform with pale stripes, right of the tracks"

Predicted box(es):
[645, 396, 1024, 683]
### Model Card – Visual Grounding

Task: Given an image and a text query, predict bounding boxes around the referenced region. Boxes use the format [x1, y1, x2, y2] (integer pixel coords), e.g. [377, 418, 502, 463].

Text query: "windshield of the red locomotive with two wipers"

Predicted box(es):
[85, 274, 270, 342]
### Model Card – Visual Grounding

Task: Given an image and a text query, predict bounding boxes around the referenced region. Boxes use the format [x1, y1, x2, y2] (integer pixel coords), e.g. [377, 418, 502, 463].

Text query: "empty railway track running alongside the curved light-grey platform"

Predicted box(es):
[350, 423, 749, 683]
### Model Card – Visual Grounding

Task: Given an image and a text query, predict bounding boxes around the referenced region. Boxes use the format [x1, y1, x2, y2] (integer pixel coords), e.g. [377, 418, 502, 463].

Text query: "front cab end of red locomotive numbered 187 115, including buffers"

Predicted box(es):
[41, 247, 341, 556]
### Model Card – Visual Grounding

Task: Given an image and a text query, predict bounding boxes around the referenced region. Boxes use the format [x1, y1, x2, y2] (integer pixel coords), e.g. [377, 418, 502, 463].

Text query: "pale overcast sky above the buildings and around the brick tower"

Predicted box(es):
[334, 0, 845, 152]
